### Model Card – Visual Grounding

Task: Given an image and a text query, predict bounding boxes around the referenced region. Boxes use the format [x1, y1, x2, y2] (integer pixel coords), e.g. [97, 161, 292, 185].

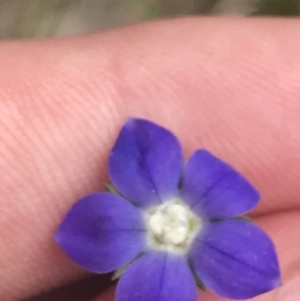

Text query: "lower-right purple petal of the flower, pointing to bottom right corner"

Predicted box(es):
[189, 219, 281, 299]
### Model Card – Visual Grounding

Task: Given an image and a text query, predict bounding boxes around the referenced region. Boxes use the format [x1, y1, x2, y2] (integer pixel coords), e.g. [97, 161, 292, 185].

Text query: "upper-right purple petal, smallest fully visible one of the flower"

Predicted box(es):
[182, 150, 259, 219]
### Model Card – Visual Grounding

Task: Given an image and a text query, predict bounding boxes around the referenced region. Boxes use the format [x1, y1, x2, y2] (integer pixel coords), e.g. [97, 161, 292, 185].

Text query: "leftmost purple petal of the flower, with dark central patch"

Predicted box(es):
[55, 193, 146, 273]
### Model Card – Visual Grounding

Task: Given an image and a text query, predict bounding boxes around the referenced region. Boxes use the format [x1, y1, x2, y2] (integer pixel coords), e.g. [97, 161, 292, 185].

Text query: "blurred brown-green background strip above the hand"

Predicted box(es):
[0, 0, 300, 39]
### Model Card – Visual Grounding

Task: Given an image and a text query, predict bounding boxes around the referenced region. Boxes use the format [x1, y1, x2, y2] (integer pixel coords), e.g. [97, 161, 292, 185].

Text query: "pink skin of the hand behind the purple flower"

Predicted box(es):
[0, 18, 300, 301]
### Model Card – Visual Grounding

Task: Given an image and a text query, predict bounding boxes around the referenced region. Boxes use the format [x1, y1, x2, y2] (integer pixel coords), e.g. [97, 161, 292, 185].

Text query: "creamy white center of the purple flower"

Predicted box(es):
[146, 199, 202, 254]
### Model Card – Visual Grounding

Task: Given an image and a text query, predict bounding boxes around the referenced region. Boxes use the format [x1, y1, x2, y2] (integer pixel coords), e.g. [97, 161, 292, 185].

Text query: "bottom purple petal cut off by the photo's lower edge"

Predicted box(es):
[117, 252, 197, 301]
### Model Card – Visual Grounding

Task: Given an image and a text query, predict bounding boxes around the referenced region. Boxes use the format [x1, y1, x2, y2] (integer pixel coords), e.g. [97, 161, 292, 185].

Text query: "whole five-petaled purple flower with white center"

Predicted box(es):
[55, 119, 281, 301]
